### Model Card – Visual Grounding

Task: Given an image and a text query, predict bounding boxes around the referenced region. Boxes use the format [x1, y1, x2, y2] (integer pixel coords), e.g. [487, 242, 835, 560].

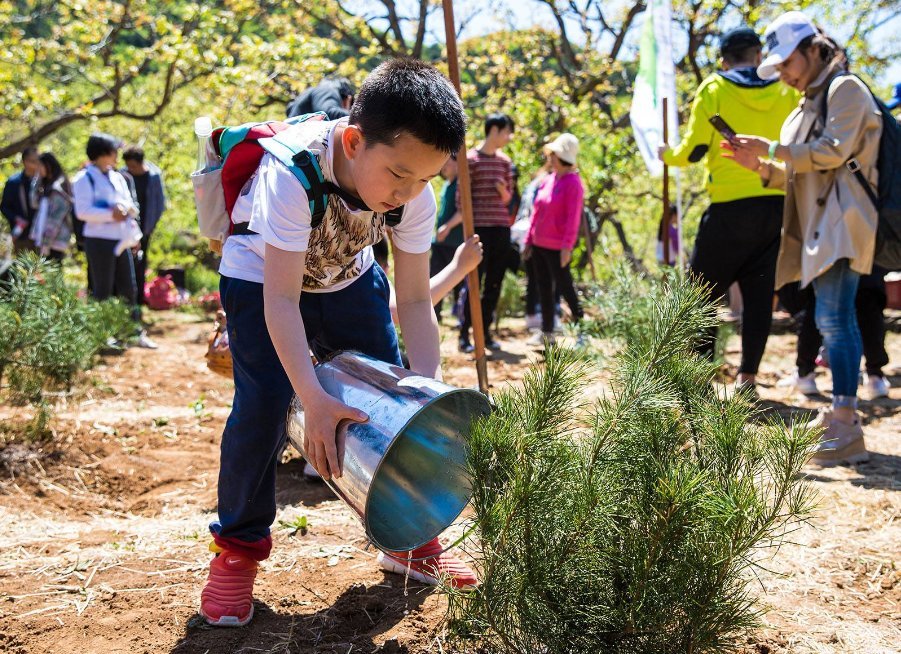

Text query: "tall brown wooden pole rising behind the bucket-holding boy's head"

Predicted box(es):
[441, 0, 488, 395]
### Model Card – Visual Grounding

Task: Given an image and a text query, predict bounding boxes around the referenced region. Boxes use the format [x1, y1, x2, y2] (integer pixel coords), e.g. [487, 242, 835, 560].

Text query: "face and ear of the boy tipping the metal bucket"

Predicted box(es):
[341, 130, 449, 213]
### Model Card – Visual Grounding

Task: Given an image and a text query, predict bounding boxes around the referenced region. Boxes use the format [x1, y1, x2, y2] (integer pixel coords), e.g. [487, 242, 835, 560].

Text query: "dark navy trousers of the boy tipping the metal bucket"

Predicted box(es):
[210, 264, 401, 560]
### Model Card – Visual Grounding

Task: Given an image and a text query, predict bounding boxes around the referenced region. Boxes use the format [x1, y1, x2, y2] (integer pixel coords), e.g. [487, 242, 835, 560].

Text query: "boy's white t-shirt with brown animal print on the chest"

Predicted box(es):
[219, 118, 437, 293]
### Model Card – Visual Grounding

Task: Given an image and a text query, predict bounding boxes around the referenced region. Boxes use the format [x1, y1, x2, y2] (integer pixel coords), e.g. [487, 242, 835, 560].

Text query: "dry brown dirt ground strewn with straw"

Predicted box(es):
[0, 312, 901, 654]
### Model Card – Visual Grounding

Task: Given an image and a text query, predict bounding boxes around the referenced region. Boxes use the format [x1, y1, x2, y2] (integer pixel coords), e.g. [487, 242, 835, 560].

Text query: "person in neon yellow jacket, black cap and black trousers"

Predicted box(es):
[659, 27, 799, 389]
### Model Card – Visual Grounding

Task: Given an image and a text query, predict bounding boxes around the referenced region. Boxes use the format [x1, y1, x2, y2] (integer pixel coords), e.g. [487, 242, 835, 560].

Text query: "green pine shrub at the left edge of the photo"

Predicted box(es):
[0, 254, 134, 420]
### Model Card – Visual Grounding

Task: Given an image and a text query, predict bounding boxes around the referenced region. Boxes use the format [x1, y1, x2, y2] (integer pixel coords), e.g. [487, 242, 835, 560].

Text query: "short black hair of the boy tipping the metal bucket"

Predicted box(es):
[350, 59, 466, 154]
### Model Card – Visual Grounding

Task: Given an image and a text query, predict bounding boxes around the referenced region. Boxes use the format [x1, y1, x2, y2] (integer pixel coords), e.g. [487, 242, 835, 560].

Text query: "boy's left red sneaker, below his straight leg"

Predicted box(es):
[200, 545, 259, 627]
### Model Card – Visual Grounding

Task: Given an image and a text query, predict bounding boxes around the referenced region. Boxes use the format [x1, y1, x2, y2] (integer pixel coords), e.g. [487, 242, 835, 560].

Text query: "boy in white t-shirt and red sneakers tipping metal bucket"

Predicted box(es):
[200, 59, 476, 626]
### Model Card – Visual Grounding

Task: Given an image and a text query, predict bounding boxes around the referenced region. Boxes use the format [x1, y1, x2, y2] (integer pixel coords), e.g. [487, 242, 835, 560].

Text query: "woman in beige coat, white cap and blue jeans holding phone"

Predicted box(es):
[726, 11, 882, 472]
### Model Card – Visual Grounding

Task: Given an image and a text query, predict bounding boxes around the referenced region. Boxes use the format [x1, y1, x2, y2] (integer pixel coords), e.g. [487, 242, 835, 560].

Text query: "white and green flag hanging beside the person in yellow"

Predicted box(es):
[629, 0, 679, 177]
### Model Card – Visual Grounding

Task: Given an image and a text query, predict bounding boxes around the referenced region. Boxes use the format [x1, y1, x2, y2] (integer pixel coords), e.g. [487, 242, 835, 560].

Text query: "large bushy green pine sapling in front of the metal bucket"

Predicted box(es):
[448, 268, 815, 654]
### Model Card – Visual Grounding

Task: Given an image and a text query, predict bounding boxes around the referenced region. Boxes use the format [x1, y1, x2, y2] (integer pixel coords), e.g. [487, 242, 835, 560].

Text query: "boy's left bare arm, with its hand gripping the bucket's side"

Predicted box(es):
[263, 243, 368, 480]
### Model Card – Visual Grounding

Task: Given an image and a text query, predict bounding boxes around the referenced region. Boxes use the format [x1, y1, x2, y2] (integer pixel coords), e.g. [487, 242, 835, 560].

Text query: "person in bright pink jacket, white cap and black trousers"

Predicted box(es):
[524, 133, 585, 345]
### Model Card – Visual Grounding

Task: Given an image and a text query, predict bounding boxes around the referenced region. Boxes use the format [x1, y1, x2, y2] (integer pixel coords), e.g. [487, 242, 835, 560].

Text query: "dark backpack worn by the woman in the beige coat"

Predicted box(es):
[822, 73, 901, 270]
